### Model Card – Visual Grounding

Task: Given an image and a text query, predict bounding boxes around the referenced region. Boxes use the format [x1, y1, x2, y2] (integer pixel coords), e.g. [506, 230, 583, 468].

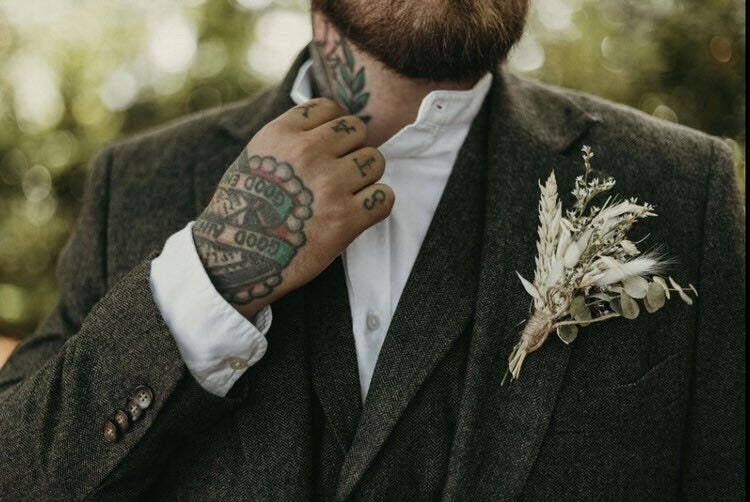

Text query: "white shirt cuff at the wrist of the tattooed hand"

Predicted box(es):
[150, 222, 273, 397]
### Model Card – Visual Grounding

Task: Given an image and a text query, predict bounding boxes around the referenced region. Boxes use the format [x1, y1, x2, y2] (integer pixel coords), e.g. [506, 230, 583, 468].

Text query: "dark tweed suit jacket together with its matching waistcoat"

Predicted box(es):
[0, 52, 745, 501]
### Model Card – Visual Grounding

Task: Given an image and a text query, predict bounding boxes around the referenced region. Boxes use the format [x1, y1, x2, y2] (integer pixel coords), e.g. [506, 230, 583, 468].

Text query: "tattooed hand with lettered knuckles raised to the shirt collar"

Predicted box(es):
[193, 98, 394, 318]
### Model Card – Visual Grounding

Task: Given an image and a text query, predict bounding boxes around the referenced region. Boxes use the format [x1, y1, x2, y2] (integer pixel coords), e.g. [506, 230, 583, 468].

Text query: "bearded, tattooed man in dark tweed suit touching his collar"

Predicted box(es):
[0, 0, 744, 500]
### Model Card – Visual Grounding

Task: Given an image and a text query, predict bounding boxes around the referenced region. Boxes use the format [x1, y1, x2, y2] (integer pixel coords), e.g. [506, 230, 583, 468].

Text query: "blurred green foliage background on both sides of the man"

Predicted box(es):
[0, 0, 745, 336]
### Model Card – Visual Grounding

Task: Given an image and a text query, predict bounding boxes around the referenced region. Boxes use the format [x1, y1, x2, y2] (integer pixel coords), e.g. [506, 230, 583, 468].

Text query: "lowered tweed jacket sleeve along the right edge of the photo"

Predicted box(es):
[679, 141, 745, 501]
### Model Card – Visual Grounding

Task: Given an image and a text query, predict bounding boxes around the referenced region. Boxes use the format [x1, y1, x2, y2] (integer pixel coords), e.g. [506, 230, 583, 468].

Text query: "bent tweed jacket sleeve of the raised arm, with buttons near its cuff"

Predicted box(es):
[0, 147, 243, 500]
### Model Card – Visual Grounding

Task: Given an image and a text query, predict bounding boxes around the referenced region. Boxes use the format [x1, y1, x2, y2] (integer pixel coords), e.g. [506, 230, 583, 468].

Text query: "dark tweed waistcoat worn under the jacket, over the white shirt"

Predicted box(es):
[304, 101, 487, 500]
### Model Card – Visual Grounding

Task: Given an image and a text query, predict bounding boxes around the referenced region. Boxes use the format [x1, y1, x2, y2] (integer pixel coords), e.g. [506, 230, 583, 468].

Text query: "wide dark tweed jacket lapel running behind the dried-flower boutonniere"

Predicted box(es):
[444, 68, 599, 500]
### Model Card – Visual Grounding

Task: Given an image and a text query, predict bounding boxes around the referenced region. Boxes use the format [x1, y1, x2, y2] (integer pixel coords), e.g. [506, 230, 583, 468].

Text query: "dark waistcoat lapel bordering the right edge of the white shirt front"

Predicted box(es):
[337, 97, 488, 500]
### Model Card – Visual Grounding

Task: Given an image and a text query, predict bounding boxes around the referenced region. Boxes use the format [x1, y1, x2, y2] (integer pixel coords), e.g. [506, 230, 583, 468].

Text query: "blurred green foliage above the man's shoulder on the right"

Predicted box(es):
[511, 0, 745, 175]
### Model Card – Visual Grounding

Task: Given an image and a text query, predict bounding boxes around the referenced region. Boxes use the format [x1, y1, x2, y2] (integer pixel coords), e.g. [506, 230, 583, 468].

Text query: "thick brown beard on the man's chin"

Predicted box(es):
[312, 0, 529, 82]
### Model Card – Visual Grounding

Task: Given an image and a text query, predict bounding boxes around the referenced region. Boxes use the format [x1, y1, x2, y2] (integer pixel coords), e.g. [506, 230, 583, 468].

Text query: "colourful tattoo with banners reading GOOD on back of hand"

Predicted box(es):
[193, 151, 313, 304]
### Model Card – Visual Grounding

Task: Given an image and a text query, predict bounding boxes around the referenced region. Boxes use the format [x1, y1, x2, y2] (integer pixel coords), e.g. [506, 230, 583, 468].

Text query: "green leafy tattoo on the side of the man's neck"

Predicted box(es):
[310, 21, 370, 122]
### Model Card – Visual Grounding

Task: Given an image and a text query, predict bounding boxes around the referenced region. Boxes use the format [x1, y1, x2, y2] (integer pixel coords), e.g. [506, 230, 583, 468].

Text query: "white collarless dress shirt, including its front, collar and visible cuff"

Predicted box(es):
[151, 61, 492, 401]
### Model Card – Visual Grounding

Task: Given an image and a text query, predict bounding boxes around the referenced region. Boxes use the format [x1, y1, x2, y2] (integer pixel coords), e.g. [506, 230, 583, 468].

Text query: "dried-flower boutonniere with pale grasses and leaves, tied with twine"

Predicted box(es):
[503, 146, 698, 382]
